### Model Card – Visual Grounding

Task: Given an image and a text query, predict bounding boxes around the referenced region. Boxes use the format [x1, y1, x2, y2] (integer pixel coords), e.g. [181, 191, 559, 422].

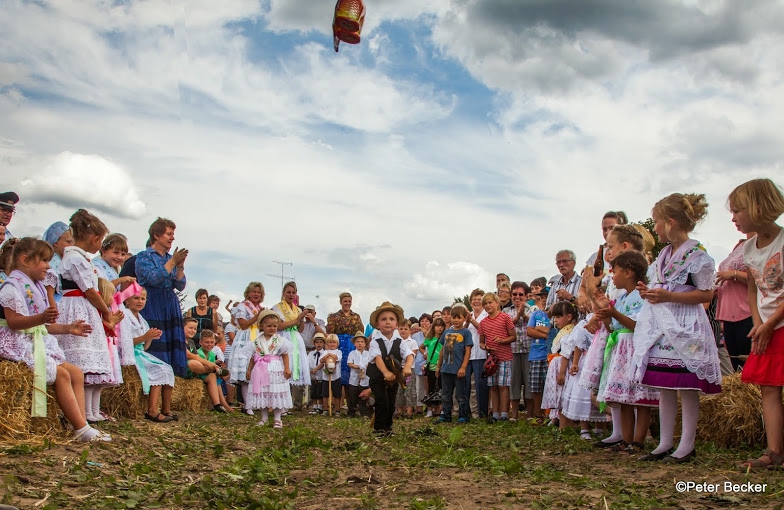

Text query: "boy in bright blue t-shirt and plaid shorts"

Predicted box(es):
[526, 287, 550, 425]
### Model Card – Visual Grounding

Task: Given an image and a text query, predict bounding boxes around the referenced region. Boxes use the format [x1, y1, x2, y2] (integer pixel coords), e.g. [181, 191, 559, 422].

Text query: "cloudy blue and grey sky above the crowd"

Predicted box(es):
[0, 0, 784, 318]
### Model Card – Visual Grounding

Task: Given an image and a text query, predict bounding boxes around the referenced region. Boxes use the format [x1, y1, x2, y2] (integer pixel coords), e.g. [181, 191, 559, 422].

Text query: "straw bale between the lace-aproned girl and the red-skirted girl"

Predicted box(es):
[697, 373, 765, 448]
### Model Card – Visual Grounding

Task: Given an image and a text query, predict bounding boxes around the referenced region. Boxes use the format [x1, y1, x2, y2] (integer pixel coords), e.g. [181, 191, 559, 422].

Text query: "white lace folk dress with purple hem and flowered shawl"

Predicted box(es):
[634, 239, 721, 394]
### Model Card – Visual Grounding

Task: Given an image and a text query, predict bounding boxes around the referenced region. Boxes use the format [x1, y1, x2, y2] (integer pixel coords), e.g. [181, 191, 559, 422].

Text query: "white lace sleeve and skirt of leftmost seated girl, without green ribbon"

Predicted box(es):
[0, 285, 65, 384]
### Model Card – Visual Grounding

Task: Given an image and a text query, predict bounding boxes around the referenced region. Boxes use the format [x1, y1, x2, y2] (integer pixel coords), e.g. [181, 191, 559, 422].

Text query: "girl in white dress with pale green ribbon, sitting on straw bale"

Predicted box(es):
[0, 237, 111, 441]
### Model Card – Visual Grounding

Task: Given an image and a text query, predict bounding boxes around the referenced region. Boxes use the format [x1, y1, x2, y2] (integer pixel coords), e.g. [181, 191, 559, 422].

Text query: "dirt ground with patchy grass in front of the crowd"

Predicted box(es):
[0, 414, 784, 509]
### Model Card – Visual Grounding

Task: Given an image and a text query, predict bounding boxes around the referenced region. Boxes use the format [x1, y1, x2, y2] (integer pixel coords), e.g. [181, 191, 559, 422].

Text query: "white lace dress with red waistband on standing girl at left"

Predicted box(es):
[57, 246, 117, 385]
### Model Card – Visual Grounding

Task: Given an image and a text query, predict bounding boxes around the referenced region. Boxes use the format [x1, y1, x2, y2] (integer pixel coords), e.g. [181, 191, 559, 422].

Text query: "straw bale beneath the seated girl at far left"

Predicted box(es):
[0, 360, 66, 439]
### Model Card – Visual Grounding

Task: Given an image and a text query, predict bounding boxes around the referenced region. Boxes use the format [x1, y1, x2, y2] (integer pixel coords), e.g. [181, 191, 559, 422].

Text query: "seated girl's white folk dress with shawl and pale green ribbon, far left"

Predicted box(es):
[0, 271, 66, 396]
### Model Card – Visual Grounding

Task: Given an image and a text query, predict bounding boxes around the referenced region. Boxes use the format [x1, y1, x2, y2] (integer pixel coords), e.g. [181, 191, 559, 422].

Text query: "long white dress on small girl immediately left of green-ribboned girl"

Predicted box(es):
[561, 320, 610, 422]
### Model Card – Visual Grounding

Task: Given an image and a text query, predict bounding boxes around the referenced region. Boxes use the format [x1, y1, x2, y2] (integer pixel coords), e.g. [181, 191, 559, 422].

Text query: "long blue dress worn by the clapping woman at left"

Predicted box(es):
[136, 248, 188, 377]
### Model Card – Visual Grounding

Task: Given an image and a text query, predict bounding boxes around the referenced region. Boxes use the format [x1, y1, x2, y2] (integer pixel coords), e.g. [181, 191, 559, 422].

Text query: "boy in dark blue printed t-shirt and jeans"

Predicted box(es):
[436, 304, 474, 423]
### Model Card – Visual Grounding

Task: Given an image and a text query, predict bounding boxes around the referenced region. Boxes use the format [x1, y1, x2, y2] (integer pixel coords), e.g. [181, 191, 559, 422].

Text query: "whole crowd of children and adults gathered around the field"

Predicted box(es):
[0, 179, 784, 469]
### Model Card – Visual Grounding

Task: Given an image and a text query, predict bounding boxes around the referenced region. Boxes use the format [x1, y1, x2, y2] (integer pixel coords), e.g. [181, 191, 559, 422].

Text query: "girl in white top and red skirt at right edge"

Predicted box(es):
[729, 179, 784, 471]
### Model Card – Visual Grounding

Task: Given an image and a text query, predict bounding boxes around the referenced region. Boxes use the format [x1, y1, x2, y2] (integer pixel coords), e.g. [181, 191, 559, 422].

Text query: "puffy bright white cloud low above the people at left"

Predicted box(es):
[20, 152, 147, 218]
